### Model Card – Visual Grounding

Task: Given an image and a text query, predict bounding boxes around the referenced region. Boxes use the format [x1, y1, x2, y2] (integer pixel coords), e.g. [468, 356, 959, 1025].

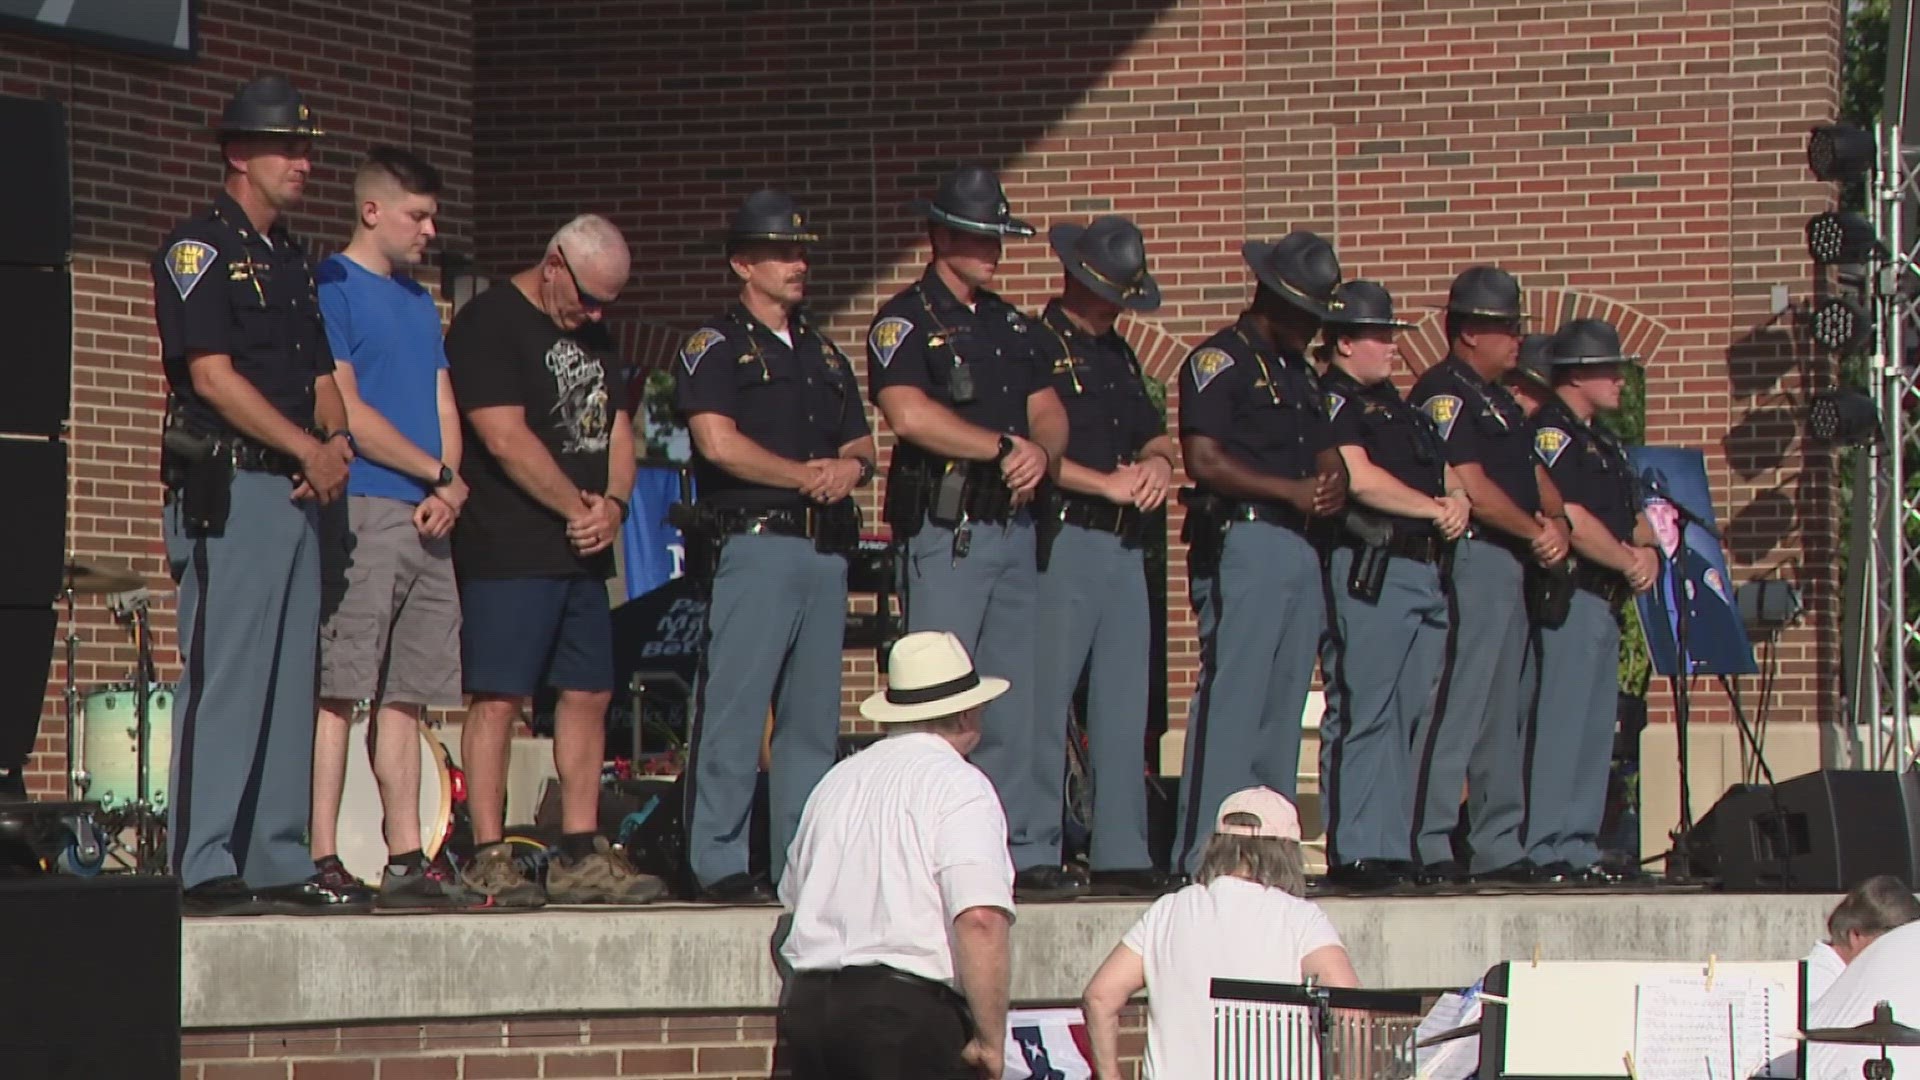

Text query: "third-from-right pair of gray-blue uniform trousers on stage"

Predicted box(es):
[1321, 546, 1448, 865]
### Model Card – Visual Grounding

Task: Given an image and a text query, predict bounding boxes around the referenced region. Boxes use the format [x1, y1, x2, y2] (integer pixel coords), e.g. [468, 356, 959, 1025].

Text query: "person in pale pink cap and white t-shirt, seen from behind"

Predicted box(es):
[1081, 788, 1359, 1080]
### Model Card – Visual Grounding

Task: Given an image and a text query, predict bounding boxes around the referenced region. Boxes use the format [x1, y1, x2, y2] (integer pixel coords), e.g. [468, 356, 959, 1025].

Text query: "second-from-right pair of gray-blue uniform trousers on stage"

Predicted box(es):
[1411, 540, 1534, 874]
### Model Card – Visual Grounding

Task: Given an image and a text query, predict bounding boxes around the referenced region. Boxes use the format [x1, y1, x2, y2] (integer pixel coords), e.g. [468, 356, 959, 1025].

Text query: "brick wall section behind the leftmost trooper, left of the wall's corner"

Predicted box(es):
[0, 0, 474, 796]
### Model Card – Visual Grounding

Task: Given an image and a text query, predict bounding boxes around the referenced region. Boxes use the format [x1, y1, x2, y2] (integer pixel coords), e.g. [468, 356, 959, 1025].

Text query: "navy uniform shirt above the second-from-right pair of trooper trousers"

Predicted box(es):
[1407, 356, 1540, 515]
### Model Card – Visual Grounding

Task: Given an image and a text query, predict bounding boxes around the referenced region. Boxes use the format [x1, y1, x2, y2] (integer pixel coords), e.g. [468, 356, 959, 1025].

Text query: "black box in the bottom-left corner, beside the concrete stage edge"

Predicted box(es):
[0, 874, 180, 1080]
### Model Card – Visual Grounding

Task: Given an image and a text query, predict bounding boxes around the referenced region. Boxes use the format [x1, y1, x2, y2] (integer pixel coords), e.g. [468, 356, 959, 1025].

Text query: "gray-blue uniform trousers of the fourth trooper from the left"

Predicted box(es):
[1008, 525, 1154, 871]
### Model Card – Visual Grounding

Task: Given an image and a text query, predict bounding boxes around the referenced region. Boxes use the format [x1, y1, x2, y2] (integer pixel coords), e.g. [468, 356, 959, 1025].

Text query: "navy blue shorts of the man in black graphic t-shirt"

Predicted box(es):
[461, 577, 612, 698]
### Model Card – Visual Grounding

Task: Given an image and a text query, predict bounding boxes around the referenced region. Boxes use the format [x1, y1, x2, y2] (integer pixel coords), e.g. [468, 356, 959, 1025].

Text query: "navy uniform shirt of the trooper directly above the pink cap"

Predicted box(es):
[1181, 315, 1334, 478]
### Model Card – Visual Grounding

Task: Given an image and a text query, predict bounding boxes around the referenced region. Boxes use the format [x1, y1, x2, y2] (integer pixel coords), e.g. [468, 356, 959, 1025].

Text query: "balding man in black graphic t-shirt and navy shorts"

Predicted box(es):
[447, 215, 664, 907]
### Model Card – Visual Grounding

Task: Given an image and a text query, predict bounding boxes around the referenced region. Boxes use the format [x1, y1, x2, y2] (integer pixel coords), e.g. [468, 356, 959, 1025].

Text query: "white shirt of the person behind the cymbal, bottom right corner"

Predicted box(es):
[1807, 922, 1920, 1080]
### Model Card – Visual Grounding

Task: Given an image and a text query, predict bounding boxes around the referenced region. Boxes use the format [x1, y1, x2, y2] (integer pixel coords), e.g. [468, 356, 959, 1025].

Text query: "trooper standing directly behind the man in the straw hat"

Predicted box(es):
[866, 165, 1085, 899]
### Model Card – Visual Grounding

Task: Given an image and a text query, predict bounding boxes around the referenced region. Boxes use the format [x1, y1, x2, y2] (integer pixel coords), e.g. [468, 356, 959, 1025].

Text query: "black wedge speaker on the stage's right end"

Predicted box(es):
[1690, 769, 1920, 892]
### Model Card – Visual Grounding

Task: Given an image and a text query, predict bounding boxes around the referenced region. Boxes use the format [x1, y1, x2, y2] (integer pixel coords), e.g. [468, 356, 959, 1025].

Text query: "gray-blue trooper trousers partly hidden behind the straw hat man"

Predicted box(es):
[900, 511, 1036, 871]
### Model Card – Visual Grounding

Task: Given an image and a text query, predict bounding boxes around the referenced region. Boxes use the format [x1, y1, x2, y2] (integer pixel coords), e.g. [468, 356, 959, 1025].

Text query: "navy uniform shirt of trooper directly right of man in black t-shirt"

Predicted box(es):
[674, 304, 870, 509]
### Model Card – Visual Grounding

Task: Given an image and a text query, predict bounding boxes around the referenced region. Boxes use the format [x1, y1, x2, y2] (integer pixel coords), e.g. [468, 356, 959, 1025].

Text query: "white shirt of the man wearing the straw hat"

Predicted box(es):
[780, 732, 1014, 984]
